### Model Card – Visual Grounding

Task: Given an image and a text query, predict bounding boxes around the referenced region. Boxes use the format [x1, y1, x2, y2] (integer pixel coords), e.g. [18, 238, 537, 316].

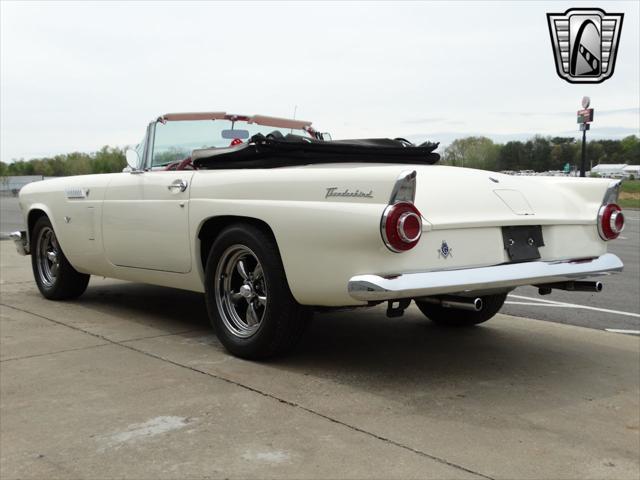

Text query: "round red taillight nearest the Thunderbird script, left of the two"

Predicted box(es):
[380, 202, 422, 252]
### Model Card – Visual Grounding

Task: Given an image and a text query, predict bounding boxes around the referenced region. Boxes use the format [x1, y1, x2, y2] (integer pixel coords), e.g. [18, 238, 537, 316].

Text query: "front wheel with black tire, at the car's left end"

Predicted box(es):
[30, 217, 91, 300]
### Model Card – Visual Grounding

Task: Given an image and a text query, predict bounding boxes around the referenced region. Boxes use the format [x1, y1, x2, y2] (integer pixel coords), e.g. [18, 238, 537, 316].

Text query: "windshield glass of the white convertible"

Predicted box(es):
[151, 120, 311, 167]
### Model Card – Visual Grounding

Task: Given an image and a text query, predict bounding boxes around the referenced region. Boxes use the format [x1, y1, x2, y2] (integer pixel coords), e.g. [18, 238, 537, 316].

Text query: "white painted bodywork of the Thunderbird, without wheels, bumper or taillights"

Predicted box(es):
[20, 163, 611, 306]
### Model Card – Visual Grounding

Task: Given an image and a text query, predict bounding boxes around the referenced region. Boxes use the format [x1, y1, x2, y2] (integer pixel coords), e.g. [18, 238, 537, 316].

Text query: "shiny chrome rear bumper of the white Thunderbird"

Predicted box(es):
[348, 253, 623, 301]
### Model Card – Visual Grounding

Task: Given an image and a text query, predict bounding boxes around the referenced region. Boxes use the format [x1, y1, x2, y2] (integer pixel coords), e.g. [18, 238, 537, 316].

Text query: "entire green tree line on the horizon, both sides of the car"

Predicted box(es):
[0, 135, 640, 177]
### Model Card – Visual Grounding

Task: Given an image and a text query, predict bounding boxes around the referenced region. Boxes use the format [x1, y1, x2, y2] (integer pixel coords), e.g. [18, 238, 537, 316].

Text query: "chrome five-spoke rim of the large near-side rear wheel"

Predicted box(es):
[214, 245, 267, 338]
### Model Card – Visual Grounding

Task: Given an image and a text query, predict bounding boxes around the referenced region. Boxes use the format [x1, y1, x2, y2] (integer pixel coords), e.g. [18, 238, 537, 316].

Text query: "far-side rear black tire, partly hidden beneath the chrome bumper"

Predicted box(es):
[414, 293, 507, 327]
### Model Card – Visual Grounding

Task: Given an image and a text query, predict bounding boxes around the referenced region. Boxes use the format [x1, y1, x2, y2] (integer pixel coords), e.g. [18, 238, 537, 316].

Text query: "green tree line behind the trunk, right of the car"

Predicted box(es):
[441, 135, 640, 172]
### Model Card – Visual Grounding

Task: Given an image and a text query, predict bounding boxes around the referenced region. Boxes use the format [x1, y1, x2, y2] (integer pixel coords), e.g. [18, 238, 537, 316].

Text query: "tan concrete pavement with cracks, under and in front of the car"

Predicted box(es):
[0, 241, 640, 479]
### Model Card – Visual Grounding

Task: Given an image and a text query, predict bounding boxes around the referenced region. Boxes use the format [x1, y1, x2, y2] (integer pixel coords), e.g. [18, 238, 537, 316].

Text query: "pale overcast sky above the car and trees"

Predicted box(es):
[0, 1, 640, 161]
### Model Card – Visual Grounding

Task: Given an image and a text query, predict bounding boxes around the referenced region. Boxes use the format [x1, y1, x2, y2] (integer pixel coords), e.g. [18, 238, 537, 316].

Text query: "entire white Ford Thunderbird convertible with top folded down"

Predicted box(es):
[12, 112, 624, 358]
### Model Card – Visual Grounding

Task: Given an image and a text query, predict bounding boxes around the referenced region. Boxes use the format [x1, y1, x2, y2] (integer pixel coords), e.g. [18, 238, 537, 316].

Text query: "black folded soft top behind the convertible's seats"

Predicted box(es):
[193, 134, 440, 169]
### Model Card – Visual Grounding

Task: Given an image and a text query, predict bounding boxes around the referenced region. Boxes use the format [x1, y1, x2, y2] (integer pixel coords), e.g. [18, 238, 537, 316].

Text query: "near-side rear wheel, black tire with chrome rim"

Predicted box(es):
[205, 224, 312, 360]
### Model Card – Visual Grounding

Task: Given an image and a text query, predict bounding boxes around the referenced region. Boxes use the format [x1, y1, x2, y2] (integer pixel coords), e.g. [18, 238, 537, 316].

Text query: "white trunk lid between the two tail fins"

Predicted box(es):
[411, 166, 610, 230]
